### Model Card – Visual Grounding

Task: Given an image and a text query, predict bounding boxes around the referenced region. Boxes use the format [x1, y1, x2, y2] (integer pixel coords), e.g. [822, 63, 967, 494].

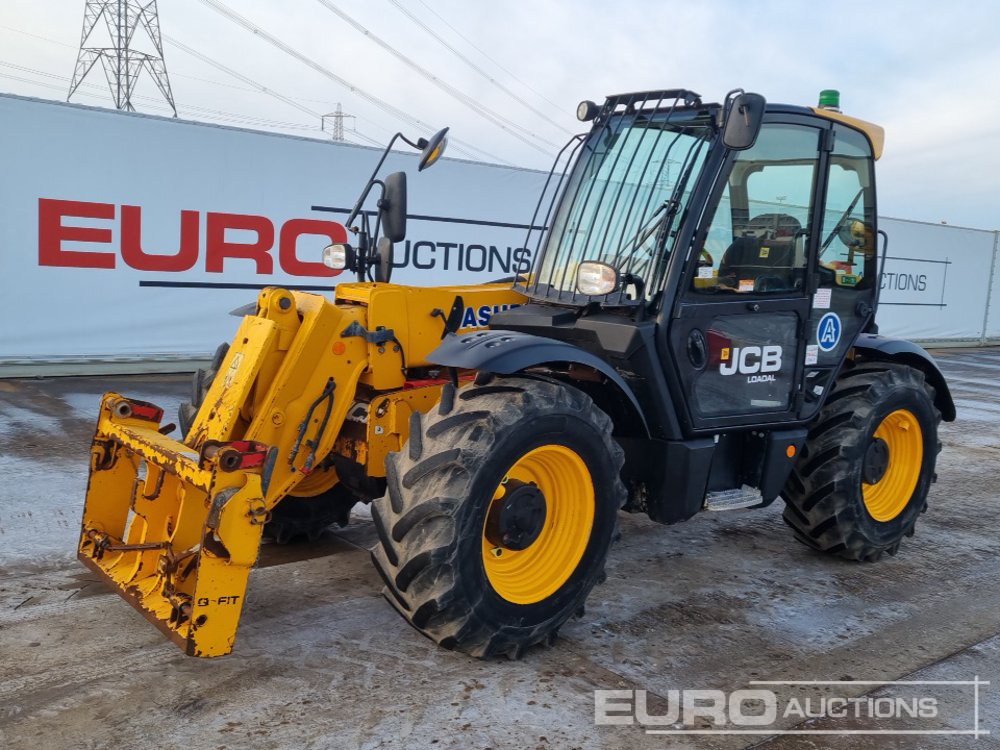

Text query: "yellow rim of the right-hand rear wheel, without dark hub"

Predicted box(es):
[861, 409, 924, 521]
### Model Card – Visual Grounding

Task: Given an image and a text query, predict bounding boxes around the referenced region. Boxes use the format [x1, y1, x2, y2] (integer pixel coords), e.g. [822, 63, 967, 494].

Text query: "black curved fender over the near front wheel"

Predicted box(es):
[427, 330, 649, 436]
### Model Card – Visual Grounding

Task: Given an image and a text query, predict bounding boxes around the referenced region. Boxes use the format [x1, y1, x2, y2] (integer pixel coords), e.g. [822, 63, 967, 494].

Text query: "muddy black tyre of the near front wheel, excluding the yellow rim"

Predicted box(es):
[372, 377, 626, 658]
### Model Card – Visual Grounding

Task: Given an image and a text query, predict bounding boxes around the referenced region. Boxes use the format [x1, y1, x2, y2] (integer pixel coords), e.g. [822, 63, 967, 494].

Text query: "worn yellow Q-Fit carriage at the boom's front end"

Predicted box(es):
[78, 393, 274, 656]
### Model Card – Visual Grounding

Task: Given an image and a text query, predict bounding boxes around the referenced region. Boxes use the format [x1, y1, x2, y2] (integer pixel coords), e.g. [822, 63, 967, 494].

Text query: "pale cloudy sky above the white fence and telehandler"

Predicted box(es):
[0, 0, 1000, 229]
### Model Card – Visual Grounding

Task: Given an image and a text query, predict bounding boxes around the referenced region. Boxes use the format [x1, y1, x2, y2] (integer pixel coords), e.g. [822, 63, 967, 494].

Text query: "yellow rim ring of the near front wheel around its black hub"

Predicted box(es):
[483, 445, 594, 604]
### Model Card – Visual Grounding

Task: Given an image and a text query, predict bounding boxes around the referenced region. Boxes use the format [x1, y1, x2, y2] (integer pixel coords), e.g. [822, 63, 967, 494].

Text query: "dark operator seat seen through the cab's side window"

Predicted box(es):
[719, 214, 805, 292]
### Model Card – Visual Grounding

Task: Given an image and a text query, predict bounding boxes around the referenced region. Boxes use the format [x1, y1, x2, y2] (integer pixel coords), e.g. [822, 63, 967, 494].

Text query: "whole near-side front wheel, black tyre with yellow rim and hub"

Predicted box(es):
[372, 377, 625, 658]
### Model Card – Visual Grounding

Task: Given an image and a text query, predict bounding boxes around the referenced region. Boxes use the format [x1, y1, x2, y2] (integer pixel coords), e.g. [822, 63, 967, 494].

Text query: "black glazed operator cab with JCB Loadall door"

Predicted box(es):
[491, 89, 882, 439]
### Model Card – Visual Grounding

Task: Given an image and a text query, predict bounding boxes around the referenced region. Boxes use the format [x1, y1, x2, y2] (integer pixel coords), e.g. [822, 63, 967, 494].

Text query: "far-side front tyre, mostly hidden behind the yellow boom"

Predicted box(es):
[177, 343, 358, 544]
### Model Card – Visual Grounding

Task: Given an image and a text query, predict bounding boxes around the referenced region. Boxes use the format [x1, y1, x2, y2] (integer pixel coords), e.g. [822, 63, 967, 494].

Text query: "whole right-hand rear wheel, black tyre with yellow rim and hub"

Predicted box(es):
[782, 362, 941, 561]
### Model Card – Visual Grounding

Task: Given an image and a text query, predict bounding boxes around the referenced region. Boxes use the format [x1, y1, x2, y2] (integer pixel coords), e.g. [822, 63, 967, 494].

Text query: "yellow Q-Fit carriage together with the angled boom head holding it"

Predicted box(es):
[78, 288, 376, 656]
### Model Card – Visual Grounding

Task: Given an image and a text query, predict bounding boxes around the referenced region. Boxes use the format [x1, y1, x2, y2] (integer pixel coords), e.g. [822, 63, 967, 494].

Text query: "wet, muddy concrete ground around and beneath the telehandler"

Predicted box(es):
[0, 350, 1000, 750]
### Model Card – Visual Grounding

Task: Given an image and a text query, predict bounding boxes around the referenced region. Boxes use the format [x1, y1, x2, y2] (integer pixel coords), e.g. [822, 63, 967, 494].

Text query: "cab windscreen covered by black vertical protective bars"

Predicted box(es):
[520, 89, 714, 305]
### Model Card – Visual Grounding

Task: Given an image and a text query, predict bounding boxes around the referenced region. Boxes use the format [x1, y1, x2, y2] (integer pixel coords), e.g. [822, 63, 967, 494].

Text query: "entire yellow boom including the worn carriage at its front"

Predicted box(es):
[78, 284, 524, 656]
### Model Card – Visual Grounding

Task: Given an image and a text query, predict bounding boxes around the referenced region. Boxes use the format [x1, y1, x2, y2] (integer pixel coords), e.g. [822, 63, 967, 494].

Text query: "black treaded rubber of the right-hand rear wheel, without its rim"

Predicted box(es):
[782, 362, 941, 561]
